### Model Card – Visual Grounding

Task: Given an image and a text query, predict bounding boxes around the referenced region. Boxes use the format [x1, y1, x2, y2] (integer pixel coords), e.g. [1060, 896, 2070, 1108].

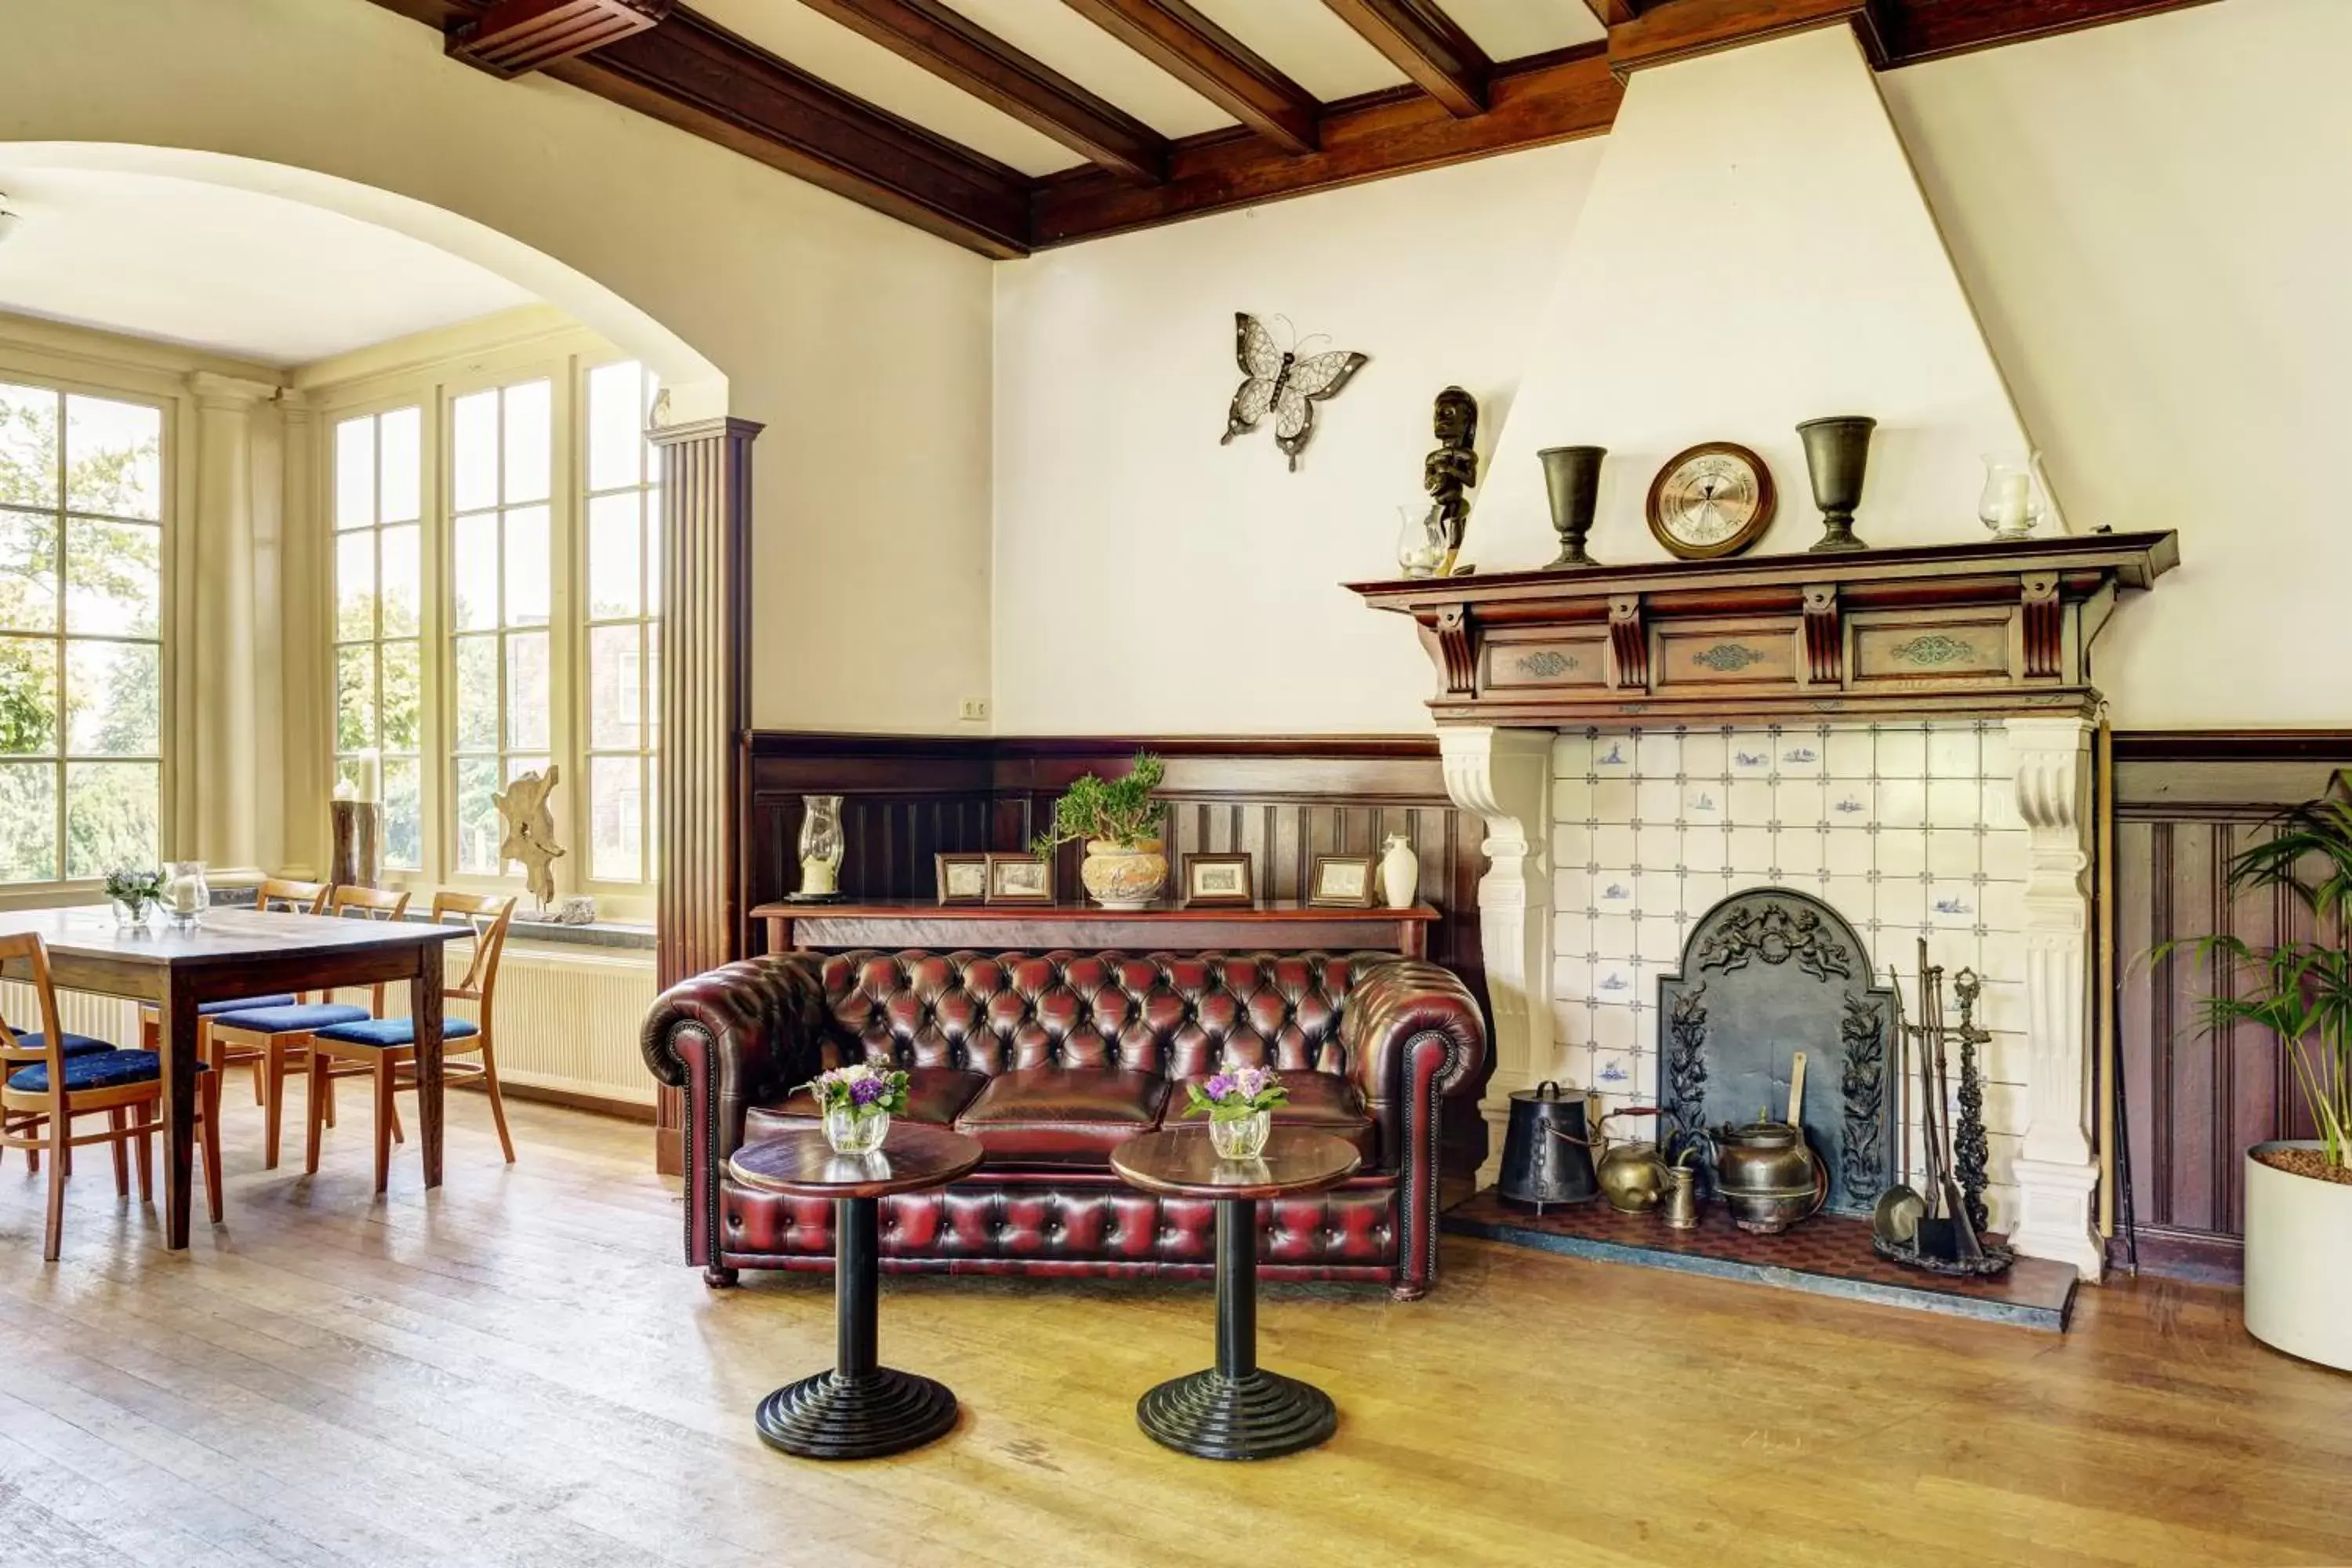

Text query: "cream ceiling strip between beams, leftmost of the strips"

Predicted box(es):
[694, 0, 1077, 174]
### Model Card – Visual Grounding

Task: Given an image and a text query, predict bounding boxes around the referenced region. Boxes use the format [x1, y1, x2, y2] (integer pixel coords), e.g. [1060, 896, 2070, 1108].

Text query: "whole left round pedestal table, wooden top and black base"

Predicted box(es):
[729, 1121, 981, 1460]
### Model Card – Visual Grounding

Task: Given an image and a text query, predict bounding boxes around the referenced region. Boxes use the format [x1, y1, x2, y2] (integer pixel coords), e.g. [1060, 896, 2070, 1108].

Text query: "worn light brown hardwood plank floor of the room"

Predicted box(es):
[0, 1105, 2352, 1568]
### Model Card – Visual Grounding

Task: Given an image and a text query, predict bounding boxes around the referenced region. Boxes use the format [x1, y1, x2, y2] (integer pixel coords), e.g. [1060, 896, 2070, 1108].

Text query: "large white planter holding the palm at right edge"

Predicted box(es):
[2246, 1140, 2352, 1370]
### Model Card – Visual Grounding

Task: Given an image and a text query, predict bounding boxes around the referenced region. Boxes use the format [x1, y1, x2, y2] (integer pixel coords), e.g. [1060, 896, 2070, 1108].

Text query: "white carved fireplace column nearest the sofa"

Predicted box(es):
[1437, 727, 1555, 1185]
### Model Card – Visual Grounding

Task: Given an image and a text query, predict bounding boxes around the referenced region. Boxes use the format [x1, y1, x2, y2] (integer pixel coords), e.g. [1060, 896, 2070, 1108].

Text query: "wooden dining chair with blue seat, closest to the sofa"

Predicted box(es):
[303, 893, 515, 1192]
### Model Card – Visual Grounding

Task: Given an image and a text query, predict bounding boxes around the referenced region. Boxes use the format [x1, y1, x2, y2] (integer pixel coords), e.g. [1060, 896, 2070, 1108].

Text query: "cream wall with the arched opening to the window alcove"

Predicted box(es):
[0, 0, 990, 731]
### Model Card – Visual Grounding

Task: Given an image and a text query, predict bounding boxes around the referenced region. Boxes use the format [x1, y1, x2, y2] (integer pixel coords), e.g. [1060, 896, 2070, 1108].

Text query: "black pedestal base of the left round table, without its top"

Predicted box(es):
[757, 1199, 955, 1460]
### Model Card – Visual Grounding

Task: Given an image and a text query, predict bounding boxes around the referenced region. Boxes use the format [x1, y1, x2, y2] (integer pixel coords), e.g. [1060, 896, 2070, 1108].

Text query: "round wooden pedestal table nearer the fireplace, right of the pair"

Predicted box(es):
[1110, 1126, 1362, 1460]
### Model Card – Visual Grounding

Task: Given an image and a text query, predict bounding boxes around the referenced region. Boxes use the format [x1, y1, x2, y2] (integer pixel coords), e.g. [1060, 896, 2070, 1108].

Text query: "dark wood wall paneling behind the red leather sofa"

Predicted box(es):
[739, 731, 1486, 1173]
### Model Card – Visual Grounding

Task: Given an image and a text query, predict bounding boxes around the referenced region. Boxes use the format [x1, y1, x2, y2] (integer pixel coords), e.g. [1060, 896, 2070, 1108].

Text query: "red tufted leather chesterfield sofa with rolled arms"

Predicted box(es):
[642, 952, 1486, 1298]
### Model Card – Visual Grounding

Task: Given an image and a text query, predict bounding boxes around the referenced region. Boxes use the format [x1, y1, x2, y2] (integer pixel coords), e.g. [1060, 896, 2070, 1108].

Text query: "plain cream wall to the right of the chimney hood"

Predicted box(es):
[1882, 0, 2352, 729]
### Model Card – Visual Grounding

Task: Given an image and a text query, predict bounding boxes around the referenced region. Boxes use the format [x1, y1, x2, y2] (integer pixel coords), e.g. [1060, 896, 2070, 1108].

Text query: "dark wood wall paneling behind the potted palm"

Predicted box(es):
[2112, 731, 2352, 1279]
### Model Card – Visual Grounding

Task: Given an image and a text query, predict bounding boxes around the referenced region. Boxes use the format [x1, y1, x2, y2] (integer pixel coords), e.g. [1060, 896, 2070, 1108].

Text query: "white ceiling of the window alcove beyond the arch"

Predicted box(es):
[0, 166, 534, 367]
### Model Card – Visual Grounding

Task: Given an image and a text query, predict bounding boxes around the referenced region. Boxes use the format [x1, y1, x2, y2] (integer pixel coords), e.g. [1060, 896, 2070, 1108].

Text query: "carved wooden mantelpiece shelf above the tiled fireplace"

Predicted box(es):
[1350, 534, 2180, 727]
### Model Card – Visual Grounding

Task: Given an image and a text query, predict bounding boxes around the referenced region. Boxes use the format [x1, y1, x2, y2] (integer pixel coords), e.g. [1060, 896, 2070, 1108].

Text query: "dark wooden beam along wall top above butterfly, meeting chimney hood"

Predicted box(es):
[1030, 45, 1625, 249]
